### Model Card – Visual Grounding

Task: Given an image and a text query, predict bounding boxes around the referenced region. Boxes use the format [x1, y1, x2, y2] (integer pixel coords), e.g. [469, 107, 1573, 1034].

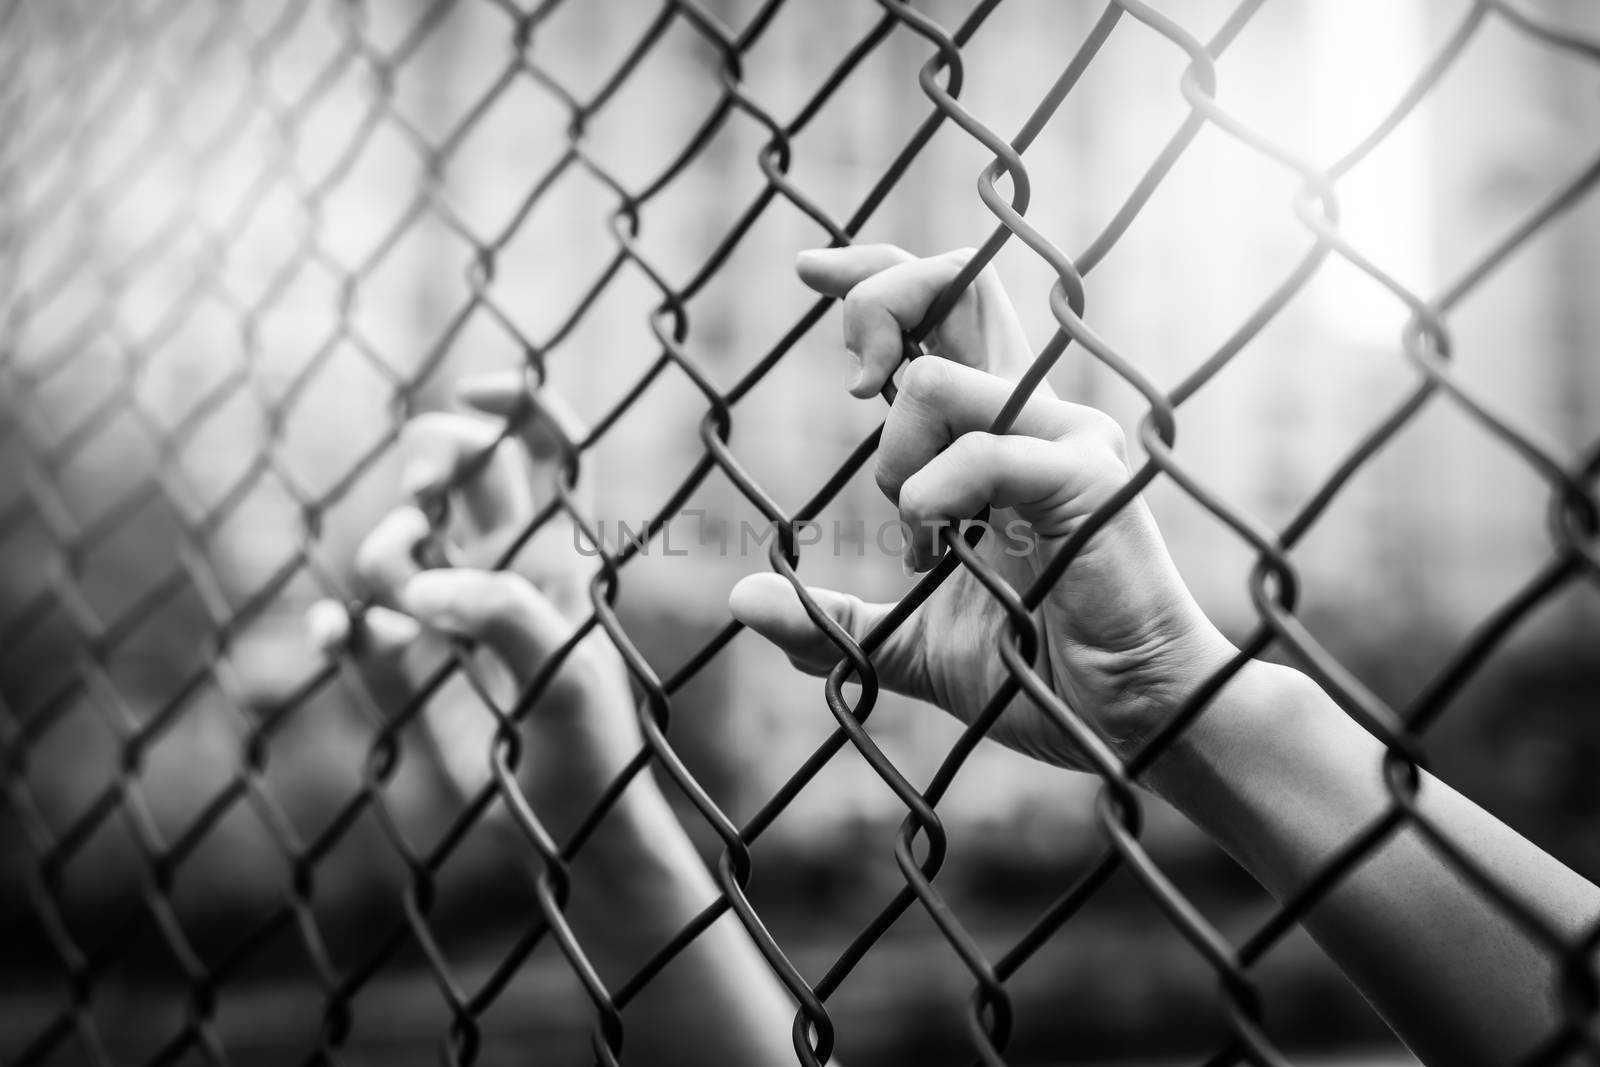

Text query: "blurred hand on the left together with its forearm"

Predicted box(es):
[309, 374, 812, 1064]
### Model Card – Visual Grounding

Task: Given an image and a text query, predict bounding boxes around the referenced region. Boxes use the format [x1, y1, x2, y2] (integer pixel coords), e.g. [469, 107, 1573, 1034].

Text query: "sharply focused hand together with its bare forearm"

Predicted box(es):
[731, 246, 1600, 1067]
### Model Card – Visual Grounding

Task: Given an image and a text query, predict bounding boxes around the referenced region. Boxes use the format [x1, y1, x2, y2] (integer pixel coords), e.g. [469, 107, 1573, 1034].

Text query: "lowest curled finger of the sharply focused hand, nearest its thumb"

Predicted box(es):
[899, 432, 1128, 571]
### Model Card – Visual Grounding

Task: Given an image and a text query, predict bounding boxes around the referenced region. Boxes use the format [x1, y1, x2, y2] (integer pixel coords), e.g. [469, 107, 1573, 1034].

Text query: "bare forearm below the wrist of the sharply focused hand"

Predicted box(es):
[1152, 664, 1600, 1067]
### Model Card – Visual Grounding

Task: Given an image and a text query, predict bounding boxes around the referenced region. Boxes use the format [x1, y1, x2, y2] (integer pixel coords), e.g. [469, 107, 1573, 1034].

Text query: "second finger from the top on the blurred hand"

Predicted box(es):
[400, 411, 533, 534]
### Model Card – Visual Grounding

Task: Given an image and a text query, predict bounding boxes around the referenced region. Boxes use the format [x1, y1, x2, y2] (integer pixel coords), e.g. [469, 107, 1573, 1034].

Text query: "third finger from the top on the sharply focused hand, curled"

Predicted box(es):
[877, 358, 1120, 502]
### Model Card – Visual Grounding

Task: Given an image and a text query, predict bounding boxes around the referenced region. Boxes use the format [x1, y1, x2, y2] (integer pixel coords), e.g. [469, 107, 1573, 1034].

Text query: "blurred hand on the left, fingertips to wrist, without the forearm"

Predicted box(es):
[307, 373, 636, 840]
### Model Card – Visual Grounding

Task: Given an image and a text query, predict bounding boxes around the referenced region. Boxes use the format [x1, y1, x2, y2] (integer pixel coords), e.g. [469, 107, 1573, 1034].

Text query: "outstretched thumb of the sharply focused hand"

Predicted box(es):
[728, 574, 928, 699]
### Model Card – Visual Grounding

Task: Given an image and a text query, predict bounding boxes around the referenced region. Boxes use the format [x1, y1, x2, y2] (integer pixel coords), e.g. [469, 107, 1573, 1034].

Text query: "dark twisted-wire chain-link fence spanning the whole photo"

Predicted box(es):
[0, 0, 1600, 1065]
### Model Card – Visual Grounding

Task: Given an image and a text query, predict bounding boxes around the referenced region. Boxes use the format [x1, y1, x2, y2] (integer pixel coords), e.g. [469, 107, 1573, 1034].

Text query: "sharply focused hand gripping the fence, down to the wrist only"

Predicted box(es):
[730, 245, 1235, 766]
